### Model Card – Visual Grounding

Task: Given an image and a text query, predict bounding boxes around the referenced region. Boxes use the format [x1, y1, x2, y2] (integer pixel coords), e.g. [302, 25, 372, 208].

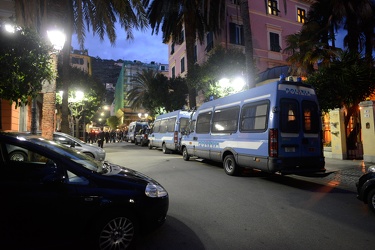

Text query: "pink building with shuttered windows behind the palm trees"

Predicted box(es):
[168, 0, 315, 77]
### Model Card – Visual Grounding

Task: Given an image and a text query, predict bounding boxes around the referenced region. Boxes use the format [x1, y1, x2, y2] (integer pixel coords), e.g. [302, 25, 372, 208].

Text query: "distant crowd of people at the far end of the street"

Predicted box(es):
[85, 128, 127, 148]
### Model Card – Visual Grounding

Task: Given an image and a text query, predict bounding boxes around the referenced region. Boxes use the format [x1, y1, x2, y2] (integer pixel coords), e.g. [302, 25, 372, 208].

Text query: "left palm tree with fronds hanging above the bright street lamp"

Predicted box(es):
[15, 0, 147, 135]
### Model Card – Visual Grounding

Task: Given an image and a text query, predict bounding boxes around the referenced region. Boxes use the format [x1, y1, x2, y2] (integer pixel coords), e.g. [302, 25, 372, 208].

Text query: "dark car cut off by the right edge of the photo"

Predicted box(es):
[356, 166, 375, 213]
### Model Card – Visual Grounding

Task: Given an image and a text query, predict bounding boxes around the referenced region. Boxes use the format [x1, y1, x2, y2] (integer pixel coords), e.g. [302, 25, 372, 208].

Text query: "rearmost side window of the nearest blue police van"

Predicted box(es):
[240, 102, 269, 132]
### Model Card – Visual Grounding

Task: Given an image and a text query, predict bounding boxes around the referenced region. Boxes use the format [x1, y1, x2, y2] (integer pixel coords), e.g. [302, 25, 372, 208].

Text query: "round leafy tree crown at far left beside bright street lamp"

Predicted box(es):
[0, 28, 55, 106]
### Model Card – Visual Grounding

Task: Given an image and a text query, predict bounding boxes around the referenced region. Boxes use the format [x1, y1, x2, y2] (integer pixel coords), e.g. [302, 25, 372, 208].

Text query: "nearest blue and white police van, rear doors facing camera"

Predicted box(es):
[181, 79, 325, 175]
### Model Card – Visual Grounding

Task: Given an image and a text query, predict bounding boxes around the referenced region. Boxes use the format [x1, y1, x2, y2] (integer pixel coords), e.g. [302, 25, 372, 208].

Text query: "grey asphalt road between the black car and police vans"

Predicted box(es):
[104, 142, 375, 250]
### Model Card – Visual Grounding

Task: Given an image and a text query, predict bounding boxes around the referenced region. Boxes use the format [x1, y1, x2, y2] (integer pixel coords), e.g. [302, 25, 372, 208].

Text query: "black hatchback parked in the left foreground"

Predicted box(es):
[0, 132, 169, 249]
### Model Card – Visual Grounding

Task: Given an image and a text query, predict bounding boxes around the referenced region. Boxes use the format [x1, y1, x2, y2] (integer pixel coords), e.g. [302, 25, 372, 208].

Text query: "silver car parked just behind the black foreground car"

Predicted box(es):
[10, 132, 106, 161]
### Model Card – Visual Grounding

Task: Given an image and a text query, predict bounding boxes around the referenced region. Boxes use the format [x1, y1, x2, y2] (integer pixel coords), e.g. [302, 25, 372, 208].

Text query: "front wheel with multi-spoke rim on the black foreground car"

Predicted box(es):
[93, 213, 138, 250]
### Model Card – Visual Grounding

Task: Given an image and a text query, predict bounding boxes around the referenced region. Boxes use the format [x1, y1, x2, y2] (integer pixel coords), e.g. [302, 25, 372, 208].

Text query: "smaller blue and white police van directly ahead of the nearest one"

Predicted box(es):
[148, 110, 191, 154]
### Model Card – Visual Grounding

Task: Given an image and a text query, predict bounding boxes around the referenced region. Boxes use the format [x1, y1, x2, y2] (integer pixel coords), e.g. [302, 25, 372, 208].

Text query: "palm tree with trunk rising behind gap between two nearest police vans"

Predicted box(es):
[144, 0, 226, 108]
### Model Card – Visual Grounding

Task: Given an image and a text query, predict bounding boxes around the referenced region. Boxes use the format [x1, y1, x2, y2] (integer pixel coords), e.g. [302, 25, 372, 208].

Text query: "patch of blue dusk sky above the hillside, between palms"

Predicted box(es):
[72, 22, 168, 64]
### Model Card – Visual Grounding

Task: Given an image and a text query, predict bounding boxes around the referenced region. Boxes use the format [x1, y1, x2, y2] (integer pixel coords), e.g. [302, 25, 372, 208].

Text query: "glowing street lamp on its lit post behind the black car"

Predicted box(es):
[42, 30, 65, 139]
